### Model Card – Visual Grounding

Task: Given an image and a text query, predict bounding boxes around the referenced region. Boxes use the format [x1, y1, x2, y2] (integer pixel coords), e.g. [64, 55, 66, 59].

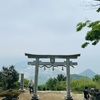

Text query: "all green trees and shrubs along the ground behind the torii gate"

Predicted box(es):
[0, 66, 100, 92]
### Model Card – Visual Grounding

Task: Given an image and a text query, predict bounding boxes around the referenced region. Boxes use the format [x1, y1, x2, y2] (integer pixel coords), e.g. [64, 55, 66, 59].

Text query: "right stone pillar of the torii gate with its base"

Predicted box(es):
[65, 59, 73, 100]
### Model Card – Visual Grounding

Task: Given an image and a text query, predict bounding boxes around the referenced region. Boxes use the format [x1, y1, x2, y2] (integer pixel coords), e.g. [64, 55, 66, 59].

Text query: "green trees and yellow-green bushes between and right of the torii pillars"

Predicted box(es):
[39, 74, 100, 92]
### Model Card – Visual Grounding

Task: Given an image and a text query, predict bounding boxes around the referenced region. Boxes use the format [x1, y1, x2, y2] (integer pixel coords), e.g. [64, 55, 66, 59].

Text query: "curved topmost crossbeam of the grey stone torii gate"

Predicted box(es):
[25, 53, 80, 59]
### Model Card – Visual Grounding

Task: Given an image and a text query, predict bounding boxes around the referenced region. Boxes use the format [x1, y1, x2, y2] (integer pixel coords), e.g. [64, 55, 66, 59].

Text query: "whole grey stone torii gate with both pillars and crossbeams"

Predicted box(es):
[25, 53, 80, 100]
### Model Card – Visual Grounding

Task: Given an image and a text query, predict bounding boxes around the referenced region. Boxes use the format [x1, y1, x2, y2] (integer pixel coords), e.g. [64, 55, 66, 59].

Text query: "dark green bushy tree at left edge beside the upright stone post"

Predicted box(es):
[1, 66, 19, 90]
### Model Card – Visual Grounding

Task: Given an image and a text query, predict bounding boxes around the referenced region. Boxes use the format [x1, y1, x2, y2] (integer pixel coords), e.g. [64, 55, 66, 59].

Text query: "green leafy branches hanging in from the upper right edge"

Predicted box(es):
[76, 0, 100, 48]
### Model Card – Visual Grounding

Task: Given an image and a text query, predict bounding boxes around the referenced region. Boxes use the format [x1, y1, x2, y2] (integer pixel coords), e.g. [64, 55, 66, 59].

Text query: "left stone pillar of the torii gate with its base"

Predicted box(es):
[31, 58, 39, 100]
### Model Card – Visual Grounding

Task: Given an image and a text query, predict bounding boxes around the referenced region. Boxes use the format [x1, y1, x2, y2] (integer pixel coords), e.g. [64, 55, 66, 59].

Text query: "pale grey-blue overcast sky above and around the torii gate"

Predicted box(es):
[0, 0, 100, 73]
